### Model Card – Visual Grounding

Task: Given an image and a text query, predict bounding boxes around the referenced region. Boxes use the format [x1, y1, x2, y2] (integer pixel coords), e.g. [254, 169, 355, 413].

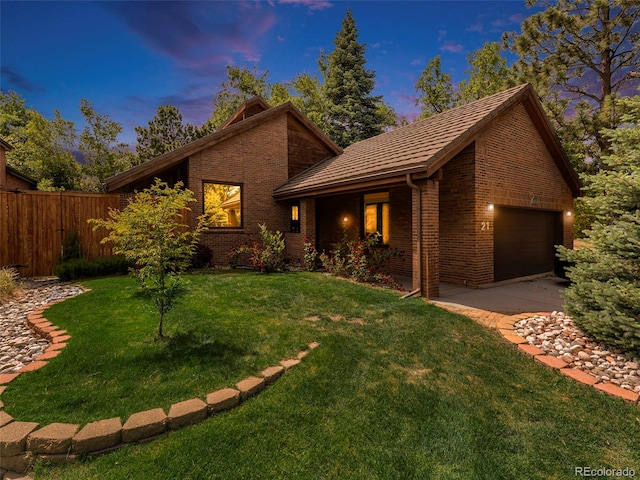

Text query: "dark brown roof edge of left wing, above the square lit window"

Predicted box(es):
[106, 99, 342, 192]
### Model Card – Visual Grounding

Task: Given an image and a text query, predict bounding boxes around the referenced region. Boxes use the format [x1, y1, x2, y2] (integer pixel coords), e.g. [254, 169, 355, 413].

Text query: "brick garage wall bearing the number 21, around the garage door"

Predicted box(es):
[439, 105, 573, 287]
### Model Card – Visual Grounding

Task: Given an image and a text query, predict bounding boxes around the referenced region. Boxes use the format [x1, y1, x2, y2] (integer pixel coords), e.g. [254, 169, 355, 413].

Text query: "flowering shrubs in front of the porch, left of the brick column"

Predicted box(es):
[318, 232, 402, 289]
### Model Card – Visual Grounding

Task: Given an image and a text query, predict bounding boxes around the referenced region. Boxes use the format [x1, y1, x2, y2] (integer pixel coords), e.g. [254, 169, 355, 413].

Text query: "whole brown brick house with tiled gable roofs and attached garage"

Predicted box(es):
[107, 85, 580, 298]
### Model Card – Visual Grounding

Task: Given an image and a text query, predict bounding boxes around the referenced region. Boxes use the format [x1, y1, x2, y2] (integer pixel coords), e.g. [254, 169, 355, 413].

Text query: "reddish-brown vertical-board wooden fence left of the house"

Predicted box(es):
[0, 190, 120, 277]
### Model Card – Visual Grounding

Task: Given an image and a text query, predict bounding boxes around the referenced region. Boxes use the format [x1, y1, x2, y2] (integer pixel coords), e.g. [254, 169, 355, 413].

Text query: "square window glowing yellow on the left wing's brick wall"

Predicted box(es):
[203, 182, 242, 228]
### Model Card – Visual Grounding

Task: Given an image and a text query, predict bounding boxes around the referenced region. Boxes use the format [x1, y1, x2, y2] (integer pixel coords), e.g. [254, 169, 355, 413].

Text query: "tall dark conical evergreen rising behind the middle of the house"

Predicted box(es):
[319, 11, 386, 147]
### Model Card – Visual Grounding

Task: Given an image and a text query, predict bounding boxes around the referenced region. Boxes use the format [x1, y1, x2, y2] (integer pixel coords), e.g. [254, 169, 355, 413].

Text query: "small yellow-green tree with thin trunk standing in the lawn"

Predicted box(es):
[89, 179, 207, 338]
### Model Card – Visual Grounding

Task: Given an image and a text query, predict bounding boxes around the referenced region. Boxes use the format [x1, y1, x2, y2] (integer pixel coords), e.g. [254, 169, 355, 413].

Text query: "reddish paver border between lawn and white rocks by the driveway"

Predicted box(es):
[431, 301, 640, 406]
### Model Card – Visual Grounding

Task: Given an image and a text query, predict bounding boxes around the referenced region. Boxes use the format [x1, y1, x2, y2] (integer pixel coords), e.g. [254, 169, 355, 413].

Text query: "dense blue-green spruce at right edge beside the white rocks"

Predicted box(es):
[560, 96, 640, 356]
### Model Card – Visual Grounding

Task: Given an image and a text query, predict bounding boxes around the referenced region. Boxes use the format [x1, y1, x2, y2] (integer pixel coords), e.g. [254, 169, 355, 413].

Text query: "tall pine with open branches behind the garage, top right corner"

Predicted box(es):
[503, 0, 640, 170]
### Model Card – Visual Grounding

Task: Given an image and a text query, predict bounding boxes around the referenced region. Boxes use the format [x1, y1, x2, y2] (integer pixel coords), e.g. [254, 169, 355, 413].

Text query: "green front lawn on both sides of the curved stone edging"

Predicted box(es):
[3, 273, 640, 480]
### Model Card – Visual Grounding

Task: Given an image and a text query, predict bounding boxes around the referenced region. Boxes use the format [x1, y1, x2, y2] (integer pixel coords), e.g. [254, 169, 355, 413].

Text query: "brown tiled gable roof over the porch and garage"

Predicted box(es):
[274, 84, 580, 198]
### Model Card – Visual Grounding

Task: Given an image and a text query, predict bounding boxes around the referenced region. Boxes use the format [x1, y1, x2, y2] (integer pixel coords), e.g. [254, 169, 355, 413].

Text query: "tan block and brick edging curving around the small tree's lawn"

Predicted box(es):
[0, 295, 319, 478]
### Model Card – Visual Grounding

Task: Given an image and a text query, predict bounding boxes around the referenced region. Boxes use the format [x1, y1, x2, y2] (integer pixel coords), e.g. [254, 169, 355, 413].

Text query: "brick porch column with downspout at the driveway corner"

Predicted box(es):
[413, 180, 440, 298]
